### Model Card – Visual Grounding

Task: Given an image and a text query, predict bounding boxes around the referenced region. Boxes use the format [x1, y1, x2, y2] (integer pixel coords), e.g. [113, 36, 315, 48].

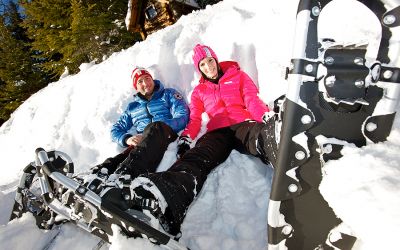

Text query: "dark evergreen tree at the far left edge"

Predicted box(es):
[0, 2, 46, 123]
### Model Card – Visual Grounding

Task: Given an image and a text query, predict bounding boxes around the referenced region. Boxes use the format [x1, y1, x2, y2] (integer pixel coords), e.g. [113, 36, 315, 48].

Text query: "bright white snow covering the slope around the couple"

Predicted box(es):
[0, 0, 400, 250]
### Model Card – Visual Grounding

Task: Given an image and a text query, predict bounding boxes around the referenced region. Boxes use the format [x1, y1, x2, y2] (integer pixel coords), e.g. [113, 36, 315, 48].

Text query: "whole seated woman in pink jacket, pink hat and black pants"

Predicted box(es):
[126, 45, 276, 235]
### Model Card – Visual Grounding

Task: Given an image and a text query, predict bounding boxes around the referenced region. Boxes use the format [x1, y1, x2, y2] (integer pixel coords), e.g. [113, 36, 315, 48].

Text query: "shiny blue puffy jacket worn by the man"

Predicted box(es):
[111, 80, 189, 147]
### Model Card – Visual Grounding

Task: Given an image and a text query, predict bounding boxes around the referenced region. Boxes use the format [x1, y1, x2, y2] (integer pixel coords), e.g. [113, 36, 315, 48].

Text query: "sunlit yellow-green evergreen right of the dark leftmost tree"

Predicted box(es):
[23, 0, 135, 76]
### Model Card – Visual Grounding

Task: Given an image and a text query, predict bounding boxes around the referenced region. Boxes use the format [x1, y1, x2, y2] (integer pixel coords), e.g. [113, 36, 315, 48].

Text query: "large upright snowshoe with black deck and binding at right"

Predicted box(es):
[268, 0, 400, 250]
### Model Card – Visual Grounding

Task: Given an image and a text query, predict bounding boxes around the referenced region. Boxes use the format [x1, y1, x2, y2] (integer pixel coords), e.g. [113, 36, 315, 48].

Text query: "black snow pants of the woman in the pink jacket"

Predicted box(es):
[148, 119, 277, 234]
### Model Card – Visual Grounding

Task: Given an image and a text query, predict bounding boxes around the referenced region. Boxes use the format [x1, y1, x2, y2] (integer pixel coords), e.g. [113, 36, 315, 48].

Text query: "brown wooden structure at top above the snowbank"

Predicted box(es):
[126, 0, 199, 40]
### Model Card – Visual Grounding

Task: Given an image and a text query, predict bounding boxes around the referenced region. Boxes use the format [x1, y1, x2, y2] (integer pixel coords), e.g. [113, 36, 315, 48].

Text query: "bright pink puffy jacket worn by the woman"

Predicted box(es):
[182, 62, 269, 139]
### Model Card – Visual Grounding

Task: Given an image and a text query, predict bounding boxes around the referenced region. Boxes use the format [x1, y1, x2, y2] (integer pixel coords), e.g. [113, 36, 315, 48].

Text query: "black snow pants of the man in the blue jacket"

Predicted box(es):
[97, 122, 178, 179]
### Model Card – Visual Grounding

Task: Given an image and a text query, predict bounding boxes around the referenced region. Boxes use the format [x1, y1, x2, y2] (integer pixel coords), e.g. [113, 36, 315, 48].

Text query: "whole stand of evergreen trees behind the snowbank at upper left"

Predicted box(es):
[0, 0, 220, 126]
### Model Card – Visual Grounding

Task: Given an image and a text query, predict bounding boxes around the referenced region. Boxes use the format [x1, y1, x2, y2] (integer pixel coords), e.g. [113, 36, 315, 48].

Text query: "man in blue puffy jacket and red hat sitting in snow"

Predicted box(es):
[92, 68, 189, 179]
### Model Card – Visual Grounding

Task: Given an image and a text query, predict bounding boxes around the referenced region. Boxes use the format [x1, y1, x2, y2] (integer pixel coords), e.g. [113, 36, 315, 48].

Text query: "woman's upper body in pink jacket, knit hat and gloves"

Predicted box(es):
[178, 44, 269, 156]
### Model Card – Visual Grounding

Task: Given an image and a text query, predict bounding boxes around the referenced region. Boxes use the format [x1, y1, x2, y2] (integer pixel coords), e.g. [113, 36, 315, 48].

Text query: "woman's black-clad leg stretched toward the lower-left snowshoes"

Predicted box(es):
[148, 128, 234, 233]
